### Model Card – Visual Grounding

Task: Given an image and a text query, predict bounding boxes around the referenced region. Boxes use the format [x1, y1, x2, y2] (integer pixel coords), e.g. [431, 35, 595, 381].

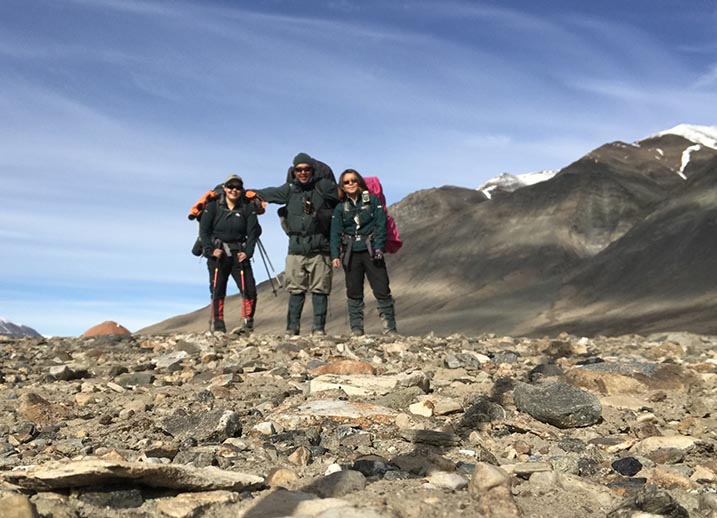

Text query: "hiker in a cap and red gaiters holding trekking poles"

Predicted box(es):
[199, 175, 261, 332]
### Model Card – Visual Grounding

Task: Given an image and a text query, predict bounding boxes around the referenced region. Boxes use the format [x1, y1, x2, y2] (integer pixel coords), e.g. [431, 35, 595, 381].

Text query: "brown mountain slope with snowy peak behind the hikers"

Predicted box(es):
[140, 125, 717, 335]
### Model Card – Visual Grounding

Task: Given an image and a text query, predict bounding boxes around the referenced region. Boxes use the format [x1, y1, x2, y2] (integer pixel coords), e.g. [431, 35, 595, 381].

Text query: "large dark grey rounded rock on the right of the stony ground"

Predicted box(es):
[513, 383, 602, 428]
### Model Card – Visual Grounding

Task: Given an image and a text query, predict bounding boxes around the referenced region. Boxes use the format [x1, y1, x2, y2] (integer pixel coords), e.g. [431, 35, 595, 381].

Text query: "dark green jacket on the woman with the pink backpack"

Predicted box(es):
[331, 194, 387, 259]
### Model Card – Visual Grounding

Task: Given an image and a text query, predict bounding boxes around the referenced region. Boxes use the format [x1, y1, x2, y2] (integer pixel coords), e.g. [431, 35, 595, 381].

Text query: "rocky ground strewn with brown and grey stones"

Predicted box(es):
[0, 333, 717, 518]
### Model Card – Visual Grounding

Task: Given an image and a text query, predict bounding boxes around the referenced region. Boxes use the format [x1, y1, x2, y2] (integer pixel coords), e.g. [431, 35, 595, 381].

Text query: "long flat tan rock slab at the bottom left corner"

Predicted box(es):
[0, 459, 264, 491]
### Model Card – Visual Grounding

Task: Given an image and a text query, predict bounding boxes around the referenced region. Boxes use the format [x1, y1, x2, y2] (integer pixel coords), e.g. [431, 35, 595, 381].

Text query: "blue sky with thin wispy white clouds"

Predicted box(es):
[0, 0, 717, 336]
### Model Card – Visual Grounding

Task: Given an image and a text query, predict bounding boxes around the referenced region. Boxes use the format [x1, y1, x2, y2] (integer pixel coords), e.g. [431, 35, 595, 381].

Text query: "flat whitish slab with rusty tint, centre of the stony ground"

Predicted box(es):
[272, 399, 398, 426]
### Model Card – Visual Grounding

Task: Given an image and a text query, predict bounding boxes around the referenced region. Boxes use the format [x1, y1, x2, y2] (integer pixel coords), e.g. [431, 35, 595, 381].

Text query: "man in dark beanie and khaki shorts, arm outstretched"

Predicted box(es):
[254, 153, 338, 335]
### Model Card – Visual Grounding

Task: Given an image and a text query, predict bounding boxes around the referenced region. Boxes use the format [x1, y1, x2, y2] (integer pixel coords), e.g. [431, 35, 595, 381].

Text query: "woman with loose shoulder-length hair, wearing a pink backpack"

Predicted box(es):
[331, 169, 397, 336]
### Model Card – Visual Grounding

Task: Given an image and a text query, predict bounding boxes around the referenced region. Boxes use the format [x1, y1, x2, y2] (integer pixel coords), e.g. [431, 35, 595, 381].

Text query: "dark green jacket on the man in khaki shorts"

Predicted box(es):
[254, 178, 339, 255]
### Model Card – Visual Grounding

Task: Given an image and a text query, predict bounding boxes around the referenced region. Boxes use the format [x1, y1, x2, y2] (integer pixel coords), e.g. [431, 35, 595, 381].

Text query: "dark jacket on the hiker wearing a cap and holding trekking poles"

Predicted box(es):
[199, 193, 261, 258]
